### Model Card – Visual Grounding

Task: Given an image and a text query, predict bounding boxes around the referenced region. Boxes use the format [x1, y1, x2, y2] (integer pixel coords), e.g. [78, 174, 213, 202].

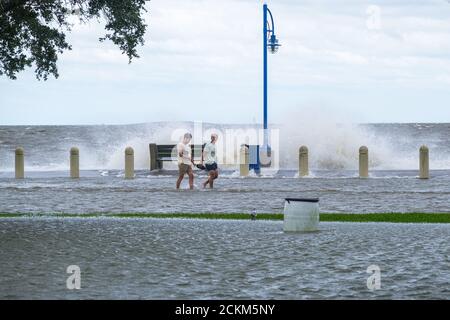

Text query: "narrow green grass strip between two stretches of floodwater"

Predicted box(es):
[0, 213, 450, 223]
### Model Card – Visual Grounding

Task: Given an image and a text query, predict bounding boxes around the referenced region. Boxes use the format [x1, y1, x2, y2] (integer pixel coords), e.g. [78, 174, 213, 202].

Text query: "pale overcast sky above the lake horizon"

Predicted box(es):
[0, 0, 450, 125]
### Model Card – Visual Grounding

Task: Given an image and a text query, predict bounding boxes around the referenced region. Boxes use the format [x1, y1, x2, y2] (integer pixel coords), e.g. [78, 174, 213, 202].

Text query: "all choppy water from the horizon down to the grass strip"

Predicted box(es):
[0, 122, 450, 213]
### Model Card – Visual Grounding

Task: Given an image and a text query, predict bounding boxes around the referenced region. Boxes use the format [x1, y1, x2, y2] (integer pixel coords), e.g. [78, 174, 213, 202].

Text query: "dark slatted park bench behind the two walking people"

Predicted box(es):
[149, 143, 205, 170]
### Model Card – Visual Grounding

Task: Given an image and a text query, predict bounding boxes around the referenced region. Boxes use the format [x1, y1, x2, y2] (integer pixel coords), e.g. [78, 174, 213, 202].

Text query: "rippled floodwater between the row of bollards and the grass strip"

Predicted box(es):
[0, 170, 450, 213]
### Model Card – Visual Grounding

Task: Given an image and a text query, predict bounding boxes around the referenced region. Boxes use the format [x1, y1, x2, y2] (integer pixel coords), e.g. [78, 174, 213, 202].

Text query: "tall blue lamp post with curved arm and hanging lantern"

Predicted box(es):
[262, 3, 281, 165]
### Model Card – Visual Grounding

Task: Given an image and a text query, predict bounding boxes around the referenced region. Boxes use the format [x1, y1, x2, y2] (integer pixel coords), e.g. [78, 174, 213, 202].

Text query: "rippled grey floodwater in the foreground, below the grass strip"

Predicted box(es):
[0, 218, 450, 299]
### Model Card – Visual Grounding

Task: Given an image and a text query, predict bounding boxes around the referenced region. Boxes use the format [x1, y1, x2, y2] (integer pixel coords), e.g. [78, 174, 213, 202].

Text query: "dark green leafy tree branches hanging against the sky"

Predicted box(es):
[0, 0, 147, 80]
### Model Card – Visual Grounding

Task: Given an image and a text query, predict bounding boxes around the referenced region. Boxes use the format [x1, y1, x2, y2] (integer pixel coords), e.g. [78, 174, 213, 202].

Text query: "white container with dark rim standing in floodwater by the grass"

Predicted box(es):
[284, 198, 319, 232]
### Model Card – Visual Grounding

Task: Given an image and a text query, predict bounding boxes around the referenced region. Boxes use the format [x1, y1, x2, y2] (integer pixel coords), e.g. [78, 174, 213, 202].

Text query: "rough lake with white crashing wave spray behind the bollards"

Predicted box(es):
[0, 121, 450, 171]
